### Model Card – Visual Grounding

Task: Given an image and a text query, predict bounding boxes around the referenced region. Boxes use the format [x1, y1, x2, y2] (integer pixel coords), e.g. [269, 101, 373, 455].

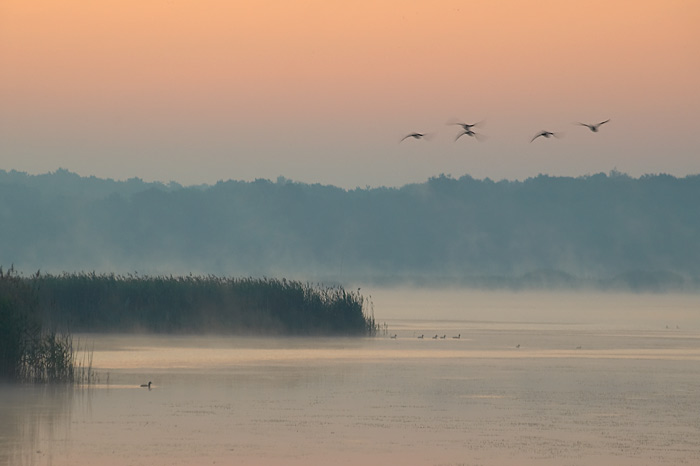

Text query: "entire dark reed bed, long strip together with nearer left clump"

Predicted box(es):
[0, 268, 386, 384]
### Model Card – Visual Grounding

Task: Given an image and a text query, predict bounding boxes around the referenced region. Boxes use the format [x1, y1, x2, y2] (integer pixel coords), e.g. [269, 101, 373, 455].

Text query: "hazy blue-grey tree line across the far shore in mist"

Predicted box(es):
[0, 170, 700, 289]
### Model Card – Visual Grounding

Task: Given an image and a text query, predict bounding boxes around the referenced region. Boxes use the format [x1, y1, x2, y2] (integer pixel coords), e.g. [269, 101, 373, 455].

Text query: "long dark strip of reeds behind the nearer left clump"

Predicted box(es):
[29, 273, 379, 336]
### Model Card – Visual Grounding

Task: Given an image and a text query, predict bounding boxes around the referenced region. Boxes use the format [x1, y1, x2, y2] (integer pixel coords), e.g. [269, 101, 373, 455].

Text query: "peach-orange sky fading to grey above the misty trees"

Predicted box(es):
[0, 0, 700, 189]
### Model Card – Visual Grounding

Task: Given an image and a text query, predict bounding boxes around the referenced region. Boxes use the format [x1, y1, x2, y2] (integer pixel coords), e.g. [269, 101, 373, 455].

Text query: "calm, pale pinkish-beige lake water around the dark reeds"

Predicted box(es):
[0, 288, 700, 466]
